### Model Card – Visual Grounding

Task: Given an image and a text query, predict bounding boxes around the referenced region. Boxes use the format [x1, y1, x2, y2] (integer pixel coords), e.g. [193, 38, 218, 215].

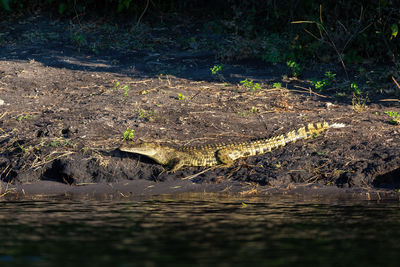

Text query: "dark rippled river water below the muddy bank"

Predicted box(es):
[0, 195, 400, 266]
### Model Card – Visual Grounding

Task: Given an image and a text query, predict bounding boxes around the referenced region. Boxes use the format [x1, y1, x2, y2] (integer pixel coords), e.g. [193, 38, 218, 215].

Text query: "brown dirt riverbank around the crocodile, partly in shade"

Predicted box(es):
[0, 16, 400, 199]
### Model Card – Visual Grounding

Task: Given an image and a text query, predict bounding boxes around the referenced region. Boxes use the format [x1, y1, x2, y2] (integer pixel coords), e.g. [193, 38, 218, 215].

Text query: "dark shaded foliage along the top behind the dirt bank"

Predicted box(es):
[0, 0, 400, 64]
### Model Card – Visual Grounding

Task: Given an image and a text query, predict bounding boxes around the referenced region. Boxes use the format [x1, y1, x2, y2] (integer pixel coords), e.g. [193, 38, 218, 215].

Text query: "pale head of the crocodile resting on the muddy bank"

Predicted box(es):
[119, 142, 176, 165]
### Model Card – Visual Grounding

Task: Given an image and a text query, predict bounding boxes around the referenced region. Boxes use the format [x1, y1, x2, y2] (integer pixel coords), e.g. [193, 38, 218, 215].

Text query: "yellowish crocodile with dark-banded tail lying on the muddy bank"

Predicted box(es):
[119, 122, 345, 172]
